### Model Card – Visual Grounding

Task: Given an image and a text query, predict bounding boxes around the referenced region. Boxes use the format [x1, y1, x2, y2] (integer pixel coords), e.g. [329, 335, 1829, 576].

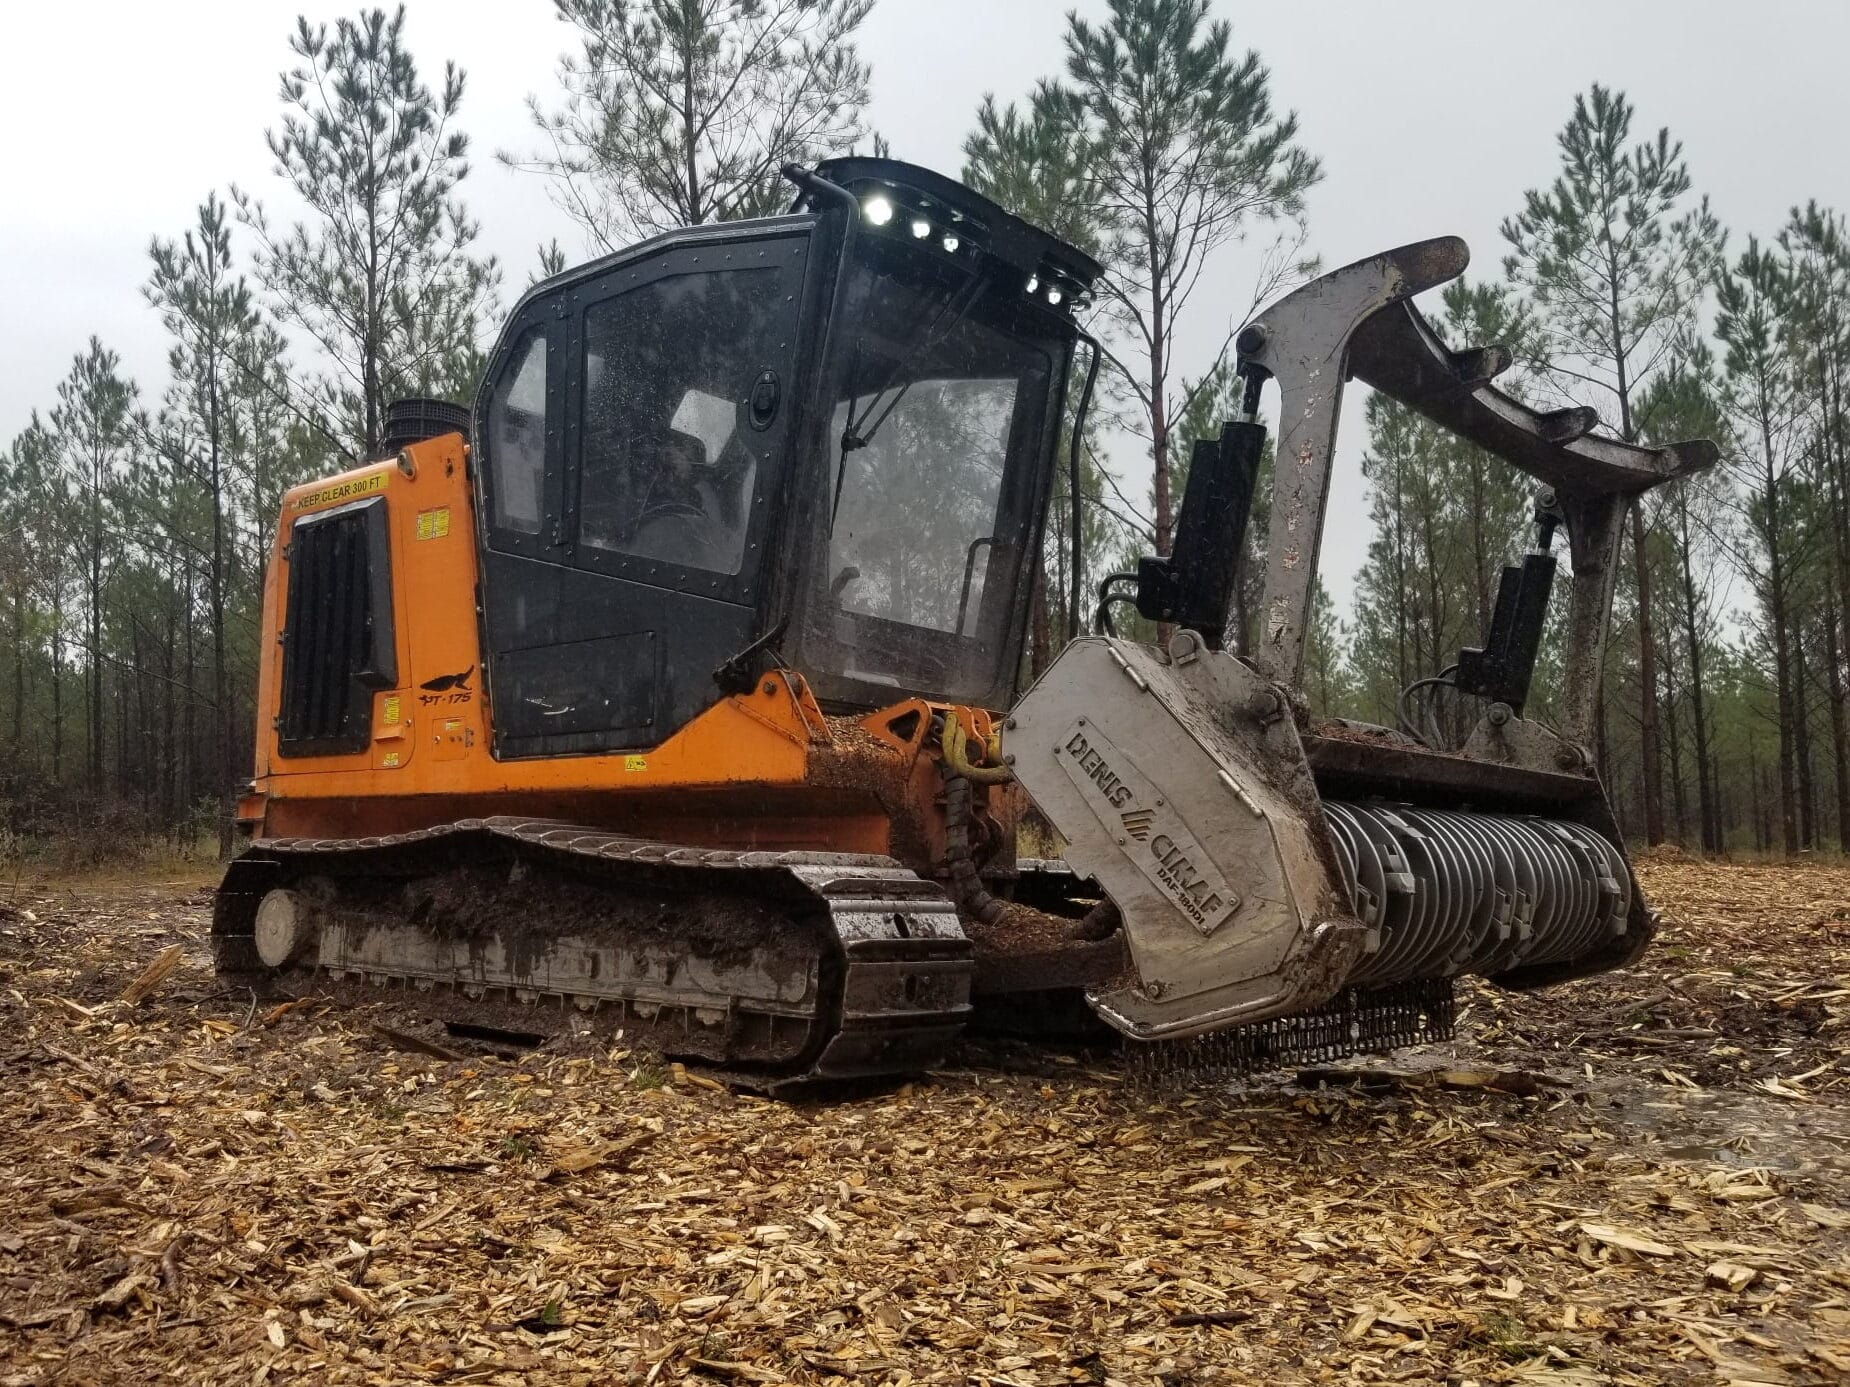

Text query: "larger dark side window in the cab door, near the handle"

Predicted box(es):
[579, 268, 786, 573]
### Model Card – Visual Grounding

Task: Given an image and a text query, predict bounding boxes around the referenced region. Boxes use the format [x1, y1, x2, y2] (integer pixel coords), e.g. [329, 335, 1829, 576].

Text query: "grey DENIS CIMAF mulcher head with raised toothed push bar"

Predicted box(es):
[1006, 237, 1715, 1065]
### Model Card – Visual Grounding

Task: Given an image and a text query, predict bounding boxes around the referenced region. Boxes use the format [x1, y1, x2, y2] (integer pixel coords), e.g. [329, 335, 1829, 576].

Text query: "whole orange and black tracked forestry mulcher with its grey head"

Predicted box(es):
[213, 157, 1713, 1086]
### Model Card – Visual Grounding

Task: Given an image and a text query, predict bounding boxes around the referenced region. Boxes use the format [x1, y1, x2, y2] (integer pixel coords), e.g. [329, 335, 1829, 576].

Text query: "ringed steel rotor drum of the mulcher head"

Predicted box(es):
[1323, 801, 1632, 986]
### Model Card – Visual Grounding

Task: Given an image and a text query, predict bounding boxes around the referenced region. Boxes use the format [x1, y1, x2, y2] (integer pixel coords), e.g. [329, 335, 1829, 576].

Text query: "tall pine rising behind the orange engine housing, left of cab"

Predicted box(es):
[231, 6, 500, 459]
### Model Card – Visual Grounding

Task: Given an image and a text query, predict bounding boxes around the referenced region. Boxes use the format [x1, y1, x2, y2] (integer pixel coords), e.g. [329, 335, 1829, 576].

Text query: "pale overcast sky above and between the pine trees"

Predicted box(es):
[0, 0, 1850, 601]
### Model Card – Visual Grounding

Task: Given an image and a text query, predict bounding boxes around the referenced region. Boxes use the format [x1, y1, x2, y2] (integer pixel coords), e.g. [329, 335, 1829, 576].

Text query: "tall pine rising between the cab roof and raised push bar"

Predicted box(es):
[1053, 0, 1321, 555]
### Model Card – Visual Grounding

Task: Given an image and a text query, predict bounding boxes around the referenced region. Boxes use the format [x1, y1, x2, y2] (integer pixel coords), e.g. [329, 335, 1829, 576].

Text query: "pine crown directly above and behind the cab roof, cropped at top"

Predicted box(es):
[501, 0, 873, 252]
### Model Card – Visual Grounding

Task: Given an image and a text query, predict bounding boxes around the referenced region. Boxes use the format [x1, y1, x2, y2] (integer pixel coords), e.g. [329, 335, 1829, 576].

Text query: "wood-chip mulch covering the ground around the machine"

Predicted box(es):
[0, 858, 1850, 1387]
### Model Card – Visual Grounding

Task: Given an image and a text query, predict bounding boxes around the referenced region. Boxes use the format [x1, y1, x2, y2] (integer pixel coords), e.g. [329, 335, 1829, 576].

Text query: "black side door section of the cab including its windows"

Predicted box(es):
[477, 218, 812, 756]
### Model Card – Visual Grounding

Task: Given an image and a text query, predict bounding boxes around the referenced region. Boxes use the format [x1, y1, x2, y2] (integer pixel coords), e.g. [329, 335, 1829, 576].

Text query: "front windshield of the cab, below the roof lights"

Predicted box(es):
[818, 244, 1064, 705]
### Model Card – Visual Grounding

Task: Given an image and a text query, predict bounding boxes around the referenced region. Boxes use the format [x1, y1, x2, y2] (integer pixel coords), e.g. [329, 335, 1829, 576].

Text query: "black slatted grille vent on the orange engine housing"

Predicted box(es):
[278, 496, 398, 756]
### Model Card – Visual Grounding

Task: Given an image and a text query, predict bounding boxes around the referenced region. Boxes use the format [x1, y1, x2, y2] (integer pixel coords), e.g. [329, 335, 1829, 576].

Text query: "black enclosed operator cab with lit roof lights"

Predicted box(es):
[475, 159, 1097, 756]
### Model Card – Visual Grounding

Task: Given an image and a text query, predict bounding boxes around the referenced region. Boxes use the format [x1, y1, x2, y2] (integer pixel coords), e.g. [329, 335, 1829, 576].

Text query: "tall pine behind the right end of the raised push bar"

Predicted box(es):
[1502, 83, 1722, 843]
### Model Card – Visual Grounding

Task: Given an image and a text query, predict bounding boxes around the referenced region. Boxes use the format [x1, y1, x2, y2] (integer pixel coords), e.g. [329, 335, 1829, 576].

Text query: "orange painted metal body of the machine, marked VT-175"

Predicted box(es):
[239, 435, 1018, 873]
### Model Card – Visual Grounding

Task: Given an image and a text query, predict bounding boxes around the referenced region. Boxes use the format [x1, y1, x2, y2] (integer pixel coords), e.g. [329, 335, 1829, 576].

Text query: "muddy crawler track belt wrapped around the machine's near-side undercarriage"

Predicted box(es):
[213, 817, 975, 1089]
